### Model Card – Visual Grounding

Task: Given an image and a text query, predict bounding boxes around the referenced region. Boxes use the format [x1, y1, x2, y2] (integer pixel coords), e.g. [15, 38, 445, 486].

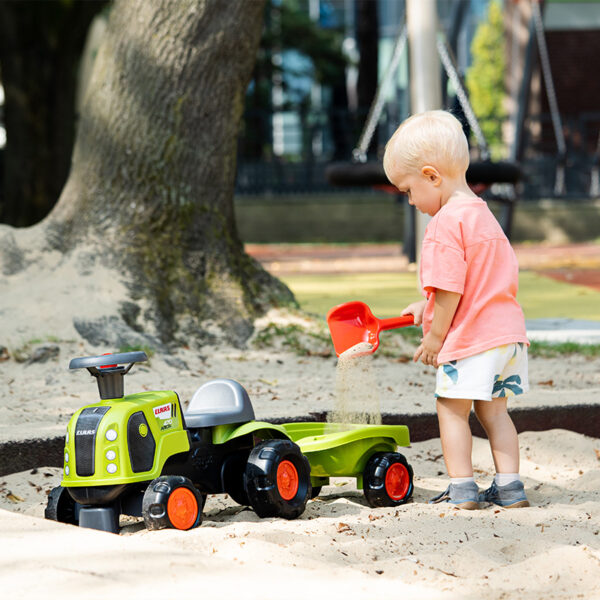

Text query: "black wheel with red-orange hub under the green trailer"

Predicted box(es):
[363, 452, 413, 507]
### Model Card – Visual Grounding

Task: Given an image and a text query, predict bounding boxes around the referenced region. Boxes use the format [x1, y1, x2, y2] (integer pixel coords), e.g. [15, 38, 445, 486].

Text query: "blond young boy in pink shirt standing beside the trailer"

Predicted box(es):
[383, 111, 529, 509]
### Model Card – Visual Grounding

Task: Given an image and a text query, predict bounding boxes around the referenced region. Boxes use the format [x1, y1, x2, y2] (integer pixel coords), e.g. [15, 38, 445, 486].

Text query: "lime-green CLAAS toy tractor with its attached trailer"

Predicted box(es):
[45, 352, 412, 533]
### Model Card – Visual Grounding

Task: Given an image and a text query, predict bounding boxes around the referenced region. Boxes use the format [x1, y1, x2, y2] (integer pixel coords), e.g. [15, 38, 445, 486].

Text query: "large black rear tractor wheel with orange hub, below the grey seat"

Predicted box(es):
[244, 440, 312, 519]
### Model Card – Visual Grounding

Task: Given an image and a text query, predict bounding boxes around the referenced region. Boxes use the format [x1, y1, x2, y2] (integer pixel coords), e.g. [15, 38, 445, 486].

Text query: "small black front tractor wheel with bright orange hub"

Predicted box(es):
[142, 475, 204, 530]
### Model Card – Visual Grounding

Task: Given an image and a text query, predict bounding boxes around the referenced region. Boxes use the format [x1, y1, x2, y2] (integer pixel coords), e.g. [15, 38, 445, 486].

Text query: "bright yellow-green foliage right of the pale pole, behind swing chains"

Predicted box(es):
[465, 0, 506, 156]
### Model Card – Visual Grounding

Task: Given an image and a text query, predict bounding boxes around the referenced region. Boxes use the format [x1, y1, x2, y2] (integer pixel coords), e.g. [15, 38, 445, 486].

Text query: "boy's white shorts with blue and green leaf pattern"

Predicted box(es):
[435, 343, 529, 400]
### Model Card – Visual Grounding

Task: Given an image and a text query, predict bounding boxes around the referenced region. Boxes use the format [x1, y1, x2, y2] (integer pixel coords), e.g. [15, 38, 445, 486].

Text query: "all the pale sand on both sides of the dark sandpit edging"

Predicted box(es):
[0, 300, 600, 600]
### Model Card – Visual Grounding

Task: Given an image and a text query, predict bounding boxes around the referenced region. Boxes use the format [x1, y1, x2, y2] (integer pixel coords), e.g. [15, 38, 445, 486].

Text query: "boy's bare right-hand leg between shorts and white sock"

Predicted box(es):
[475, 398, 519, 473]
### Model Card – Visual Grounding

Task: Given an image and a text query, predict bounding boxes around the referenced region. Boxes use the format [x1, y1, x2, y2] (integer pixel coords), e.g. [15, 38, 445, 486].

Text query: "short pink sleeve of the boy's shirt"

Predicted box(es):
[421, 239, 467, 294]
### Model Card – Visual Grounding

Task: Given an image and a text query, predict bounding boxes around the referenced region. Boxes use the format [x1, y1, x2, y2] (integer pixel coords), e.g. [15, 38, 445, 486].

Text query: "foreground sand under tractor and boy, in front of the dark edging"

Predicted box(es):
[0, 430, 600, 599]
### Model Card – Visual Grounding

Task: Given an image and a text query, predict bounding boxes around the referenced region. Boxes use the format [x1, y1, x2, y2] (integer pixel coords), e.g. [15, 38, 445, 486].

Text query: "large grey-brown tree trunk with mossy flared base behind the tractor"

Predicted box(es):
[0, 0, 293, 352]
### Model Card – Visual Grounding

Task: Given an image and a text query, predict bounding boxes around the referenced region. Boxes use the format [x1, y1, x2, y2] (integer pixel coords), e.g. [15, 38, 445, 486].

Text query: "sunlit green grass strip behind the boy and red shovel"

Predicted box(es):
[282, 271, 600, 321]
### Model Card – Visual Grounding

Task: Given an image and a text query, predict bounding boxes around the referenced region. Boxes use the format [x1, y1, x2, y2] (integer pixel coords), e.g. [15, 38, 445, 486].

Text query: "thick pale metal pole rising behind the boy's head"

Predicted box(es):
[406, 0, 442, 262]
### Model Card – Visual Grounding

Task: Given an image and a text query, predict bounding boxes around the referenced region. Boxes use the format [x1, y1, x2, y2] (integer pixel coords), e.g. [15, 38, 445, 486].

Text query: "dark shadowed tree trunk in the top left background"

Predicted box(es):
[0, 0, 105, 227]
